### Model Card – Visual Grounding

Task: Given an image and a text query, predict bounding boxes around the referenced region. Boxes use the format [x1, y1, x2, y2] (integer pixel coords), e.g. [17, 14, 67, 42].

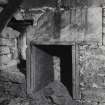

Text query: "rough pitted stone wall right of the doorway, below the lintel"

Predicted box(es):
[79, 44, 105, 105]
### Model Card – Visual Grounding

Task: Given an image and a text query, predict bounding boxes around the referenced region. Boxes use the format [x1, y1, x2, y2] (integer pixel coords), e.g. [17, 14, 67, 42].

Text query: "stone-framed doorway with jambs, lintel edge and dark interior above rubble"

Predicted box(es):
[27, 41, 80, 99]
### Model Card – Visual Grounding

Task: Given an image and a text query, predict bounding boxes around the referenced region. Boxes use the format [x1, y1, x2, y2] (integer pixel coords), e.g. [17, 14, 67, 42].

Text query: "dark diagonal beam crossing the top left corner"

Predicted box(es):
[0, 0, 23, 31]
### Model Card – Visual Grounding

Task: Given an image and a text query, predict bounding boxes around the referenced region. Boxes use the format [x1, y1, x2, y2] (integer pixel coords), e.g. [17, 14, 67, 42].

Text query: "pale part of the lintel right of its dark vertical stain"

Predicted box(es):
[60, 7, 102, 43]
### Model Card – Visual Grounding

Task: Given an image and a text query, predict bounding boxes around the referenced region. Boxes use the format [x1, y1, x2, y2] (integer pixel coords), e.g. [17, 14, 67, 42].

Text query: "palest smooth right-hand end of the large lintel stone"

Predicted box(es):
[85, 7, 102, 42]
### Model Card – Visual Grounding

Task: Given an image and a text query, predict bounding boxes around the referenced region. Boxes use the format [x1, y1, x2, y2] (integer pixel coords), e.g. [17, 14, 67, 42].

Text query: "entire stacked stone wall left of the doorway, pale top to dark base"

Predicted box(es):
[0, 27, 26, 104]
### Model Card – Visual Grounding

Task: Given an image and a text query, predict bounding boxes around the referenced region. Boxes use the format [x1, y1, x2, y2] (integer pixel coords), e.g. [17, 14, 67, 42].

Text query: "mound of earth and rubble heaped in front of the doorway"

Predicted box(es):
[5, 81, 80, 105]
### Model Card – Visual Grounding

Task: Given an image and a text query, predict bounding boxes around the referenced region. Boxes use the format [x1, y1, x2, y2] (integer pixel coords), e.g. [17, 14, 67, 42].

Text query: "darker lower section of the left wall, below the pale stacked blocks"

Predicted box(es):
[0, 70, 26, 102]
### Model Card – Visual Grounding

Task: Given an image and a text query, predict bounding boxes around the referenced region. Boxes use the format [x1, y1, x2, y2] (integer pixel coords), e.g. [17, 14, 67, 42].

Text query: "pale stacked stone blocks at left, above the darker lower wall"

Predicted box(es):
[0, 27, 20, 66]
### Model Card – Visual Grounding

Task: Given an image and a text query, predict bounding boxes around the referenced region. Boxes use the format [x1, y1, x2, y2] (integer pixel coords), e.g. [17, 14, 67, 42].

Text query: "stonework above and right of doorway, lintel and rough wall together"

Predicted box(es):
[24, 6, 105, 105]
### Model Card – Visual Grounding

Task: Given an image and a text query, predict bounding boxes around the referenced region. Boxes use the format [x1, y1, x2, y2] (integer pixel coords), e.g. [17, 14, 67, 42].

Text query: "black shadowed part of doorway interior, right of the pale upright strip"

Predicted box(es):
[35, 45, 73, 96]
